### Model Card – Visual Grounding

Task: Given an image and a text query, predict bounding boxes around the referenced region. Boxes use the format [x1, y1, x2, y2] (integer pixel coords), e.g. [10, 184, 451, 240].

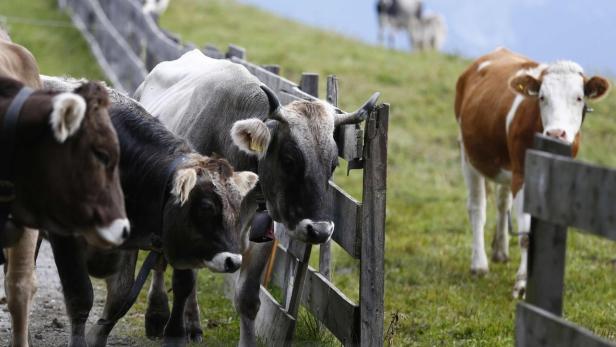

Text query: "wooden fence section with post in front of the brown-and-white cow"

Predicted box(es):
[515, 135, 616, 347]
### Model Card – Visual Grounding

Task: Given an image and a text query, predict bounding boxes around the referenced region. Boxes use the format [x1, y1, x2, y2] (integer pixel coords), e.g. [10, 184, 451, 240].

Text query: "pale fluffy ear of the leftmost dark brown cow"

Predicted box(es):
[49, 93, 86, 143]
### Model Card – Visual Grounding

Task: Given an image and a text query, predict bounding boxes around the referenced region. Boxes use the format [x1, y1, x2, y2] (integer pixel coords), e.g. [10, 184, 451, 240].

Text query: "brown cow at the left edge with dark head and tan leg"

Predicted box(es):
[0, 30, 129, 346]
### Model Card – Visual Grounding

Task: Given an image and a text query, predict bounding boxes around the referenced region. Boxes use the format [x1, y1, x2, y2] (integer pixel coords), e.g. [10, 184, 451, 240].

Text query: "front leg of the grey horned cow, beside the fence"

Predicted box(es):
[234, 242, 273, 347]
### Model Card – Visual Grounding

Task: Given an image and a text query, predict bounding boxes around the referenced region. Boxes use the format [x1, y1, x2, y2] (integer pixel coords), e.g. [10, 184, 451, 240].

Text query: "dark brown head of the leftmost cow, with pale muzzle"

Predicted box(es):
[0, 78, 129, 247]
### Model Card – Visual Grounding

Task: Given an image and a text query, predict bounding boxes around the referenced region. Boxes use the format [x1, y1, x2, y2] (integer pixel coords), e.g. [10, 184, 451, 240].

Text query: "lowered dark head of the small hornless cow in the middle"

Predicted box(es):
[163, 153, 258, 272]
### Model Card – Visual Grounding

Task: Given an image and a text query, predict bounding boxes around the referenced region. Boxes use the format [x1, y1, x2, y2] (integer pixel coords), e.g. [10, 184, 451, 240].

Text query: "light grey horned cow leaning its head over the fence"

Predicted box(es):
[135, 50, 378, 346]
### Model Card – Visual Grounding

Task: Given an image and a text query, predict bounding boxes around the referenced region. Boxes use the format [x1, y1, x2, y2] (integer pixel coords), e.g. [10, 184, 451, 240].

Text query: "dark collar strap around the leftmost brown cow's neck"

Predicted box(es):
[0, 86, 34, 264]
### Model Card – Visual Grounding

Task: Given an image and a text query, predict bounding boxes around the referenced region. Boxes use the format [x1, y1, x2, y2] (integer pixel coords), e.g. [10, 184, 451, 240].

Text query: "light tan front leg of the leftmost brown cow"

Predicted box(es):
[4, 228, 39, 347]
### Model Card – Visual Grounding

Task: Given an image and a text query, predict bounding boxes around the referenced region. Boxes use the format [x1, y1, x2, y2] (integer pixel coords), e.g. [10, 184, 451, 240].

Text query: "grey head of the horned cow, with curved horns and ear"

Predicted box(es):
[231, 86, 378, 244]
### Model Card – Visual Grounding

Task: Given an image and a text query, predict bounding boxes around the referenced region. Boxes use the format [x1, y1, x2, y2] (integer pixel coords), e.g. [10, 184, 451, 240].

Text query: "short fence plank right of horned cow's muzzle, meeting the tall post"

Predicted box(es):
[329, 181, 362, 259]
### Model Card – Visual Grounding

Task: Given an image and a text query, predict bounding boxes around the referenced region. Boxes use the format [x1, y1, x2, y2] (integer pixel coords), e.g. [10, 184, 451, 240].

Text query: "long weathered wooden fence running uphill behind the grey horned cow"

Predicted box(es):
[59, 0, 389, 346]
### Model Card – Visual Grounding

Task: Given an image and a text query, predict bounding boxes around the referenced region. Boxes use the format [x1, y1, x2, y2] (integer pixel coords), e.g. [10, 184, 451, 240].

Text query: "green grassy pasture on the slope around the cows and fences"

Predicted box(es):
[0, 0, 616, 346]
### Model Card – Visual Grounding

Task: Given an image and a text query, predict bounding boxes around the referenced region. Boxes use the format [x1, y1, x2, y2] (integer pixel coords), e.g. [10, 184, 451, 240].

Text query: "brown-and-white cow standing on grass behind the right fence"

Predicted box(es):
[454, 48, 610, 298]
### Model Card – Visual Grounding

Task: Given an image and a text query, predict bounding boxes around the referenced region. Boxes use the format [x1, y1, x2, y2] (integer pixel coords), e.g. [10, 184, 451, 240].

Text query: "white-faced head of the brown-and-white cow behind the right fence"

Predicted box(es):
[509, 61, 610, 143]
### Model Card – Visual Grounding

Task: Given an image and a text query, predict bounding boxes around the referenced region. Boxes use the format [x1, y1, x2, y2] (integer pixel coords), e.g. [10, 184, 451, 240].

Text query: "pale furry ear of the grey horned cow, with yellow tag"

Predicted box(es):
[231, 118, 271, 158]
